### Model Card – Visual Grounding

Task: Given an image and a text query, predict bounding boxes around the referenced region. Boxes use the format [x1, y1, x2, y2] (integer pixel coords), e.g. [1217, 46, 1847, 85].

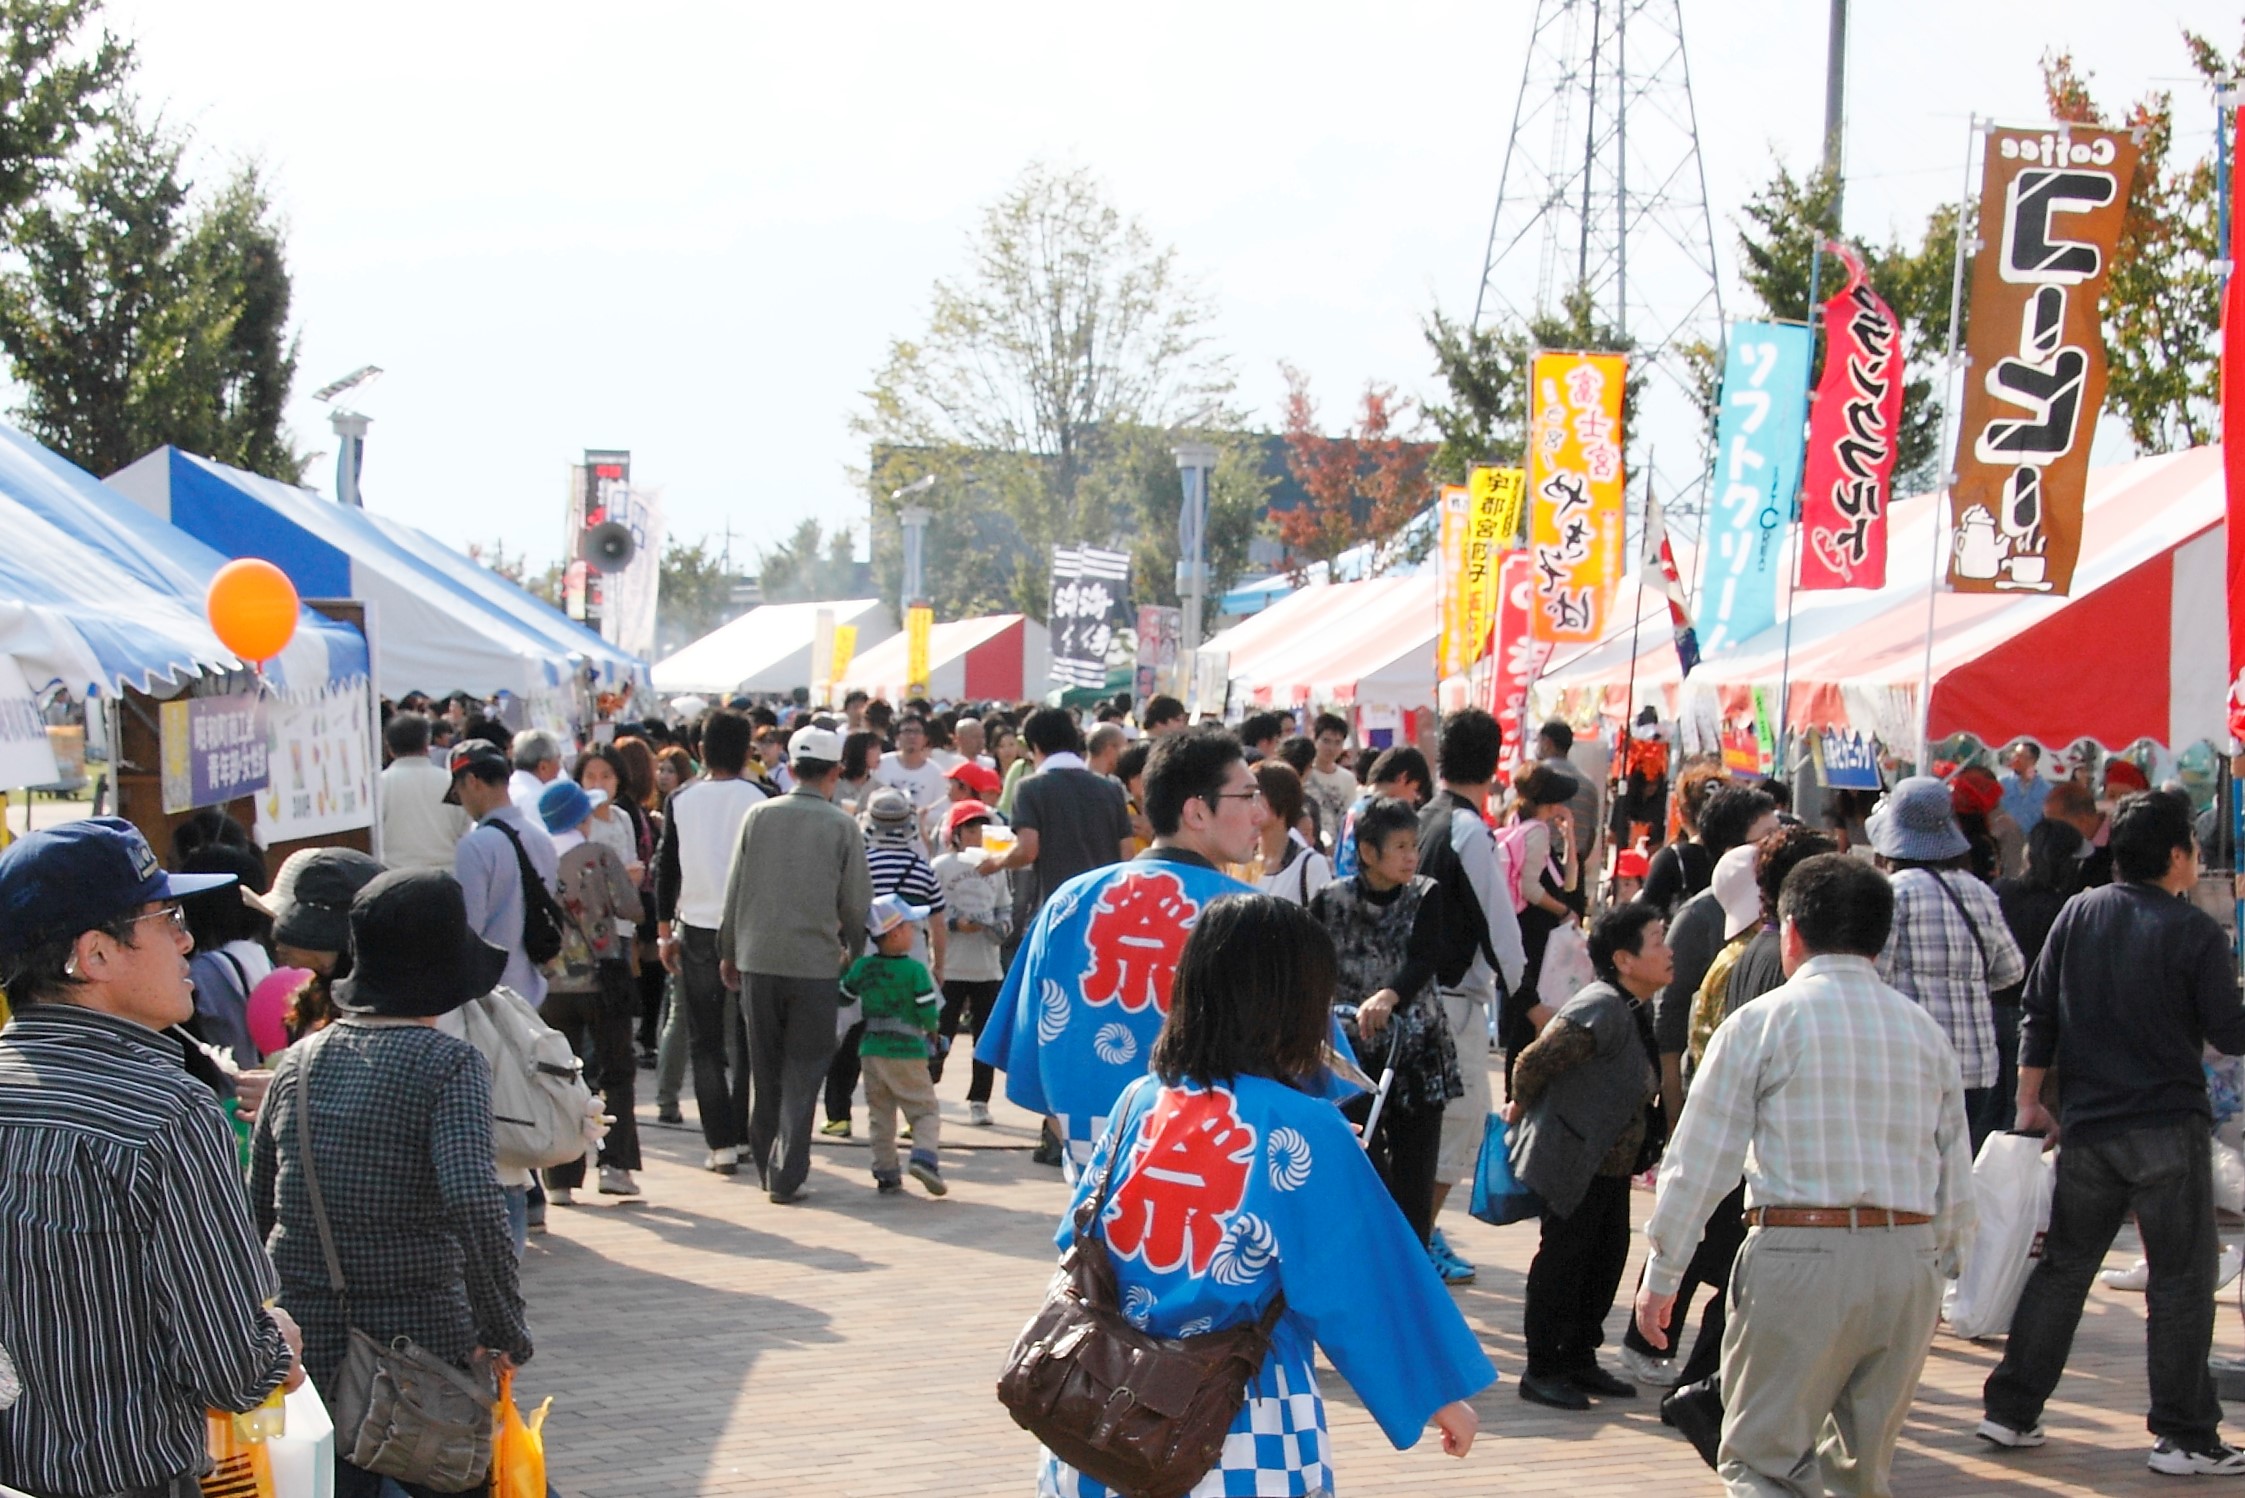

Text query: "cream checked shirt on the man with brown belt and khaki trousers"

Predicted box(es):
[1646, 954, 1973, 1296]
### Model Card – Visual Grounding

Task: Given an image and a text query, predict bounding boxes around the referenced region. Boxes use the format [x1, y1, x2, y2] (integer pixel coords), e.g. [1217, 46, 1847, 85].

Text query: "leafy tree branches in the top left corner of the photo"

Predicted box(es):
[0, 0, 132, 218]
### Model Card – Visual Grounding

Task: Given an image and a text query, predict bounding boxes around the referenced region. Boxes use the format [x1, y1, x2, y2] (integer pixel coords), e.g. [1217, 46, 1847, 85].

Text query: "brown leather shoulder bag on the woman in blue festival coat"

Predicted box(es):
[997, 1082, 1286, 1498]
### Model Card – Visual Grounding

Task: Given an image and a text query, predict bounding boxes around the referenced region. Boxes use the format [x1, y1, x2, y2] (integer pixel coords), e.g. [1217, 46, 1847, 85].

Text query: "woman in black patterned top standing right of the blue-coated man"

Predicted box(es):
[1309, 797, 1466, 1242]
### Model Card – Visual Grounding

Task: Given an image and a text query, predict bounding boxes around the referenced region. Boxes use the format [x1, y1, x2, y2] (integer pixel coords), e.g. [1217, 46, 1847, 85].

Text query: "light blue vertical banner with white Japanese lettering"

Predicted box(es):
[1699, 323, 1809, 656]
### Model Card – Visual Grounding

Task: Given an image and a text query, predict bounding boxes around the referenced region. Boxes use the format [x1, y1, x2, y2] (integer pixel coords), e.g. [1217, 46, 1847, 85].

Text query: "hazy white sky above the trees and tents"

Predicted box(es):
[96, 0, 2238, 561]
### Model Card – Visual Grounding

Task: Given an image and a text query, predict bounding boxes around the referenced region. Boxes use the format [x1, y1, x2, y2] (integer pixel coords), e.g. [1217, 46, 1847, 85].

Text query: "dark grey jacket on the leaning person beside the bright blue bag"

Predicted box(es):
[1511, 984, 1655, 1217]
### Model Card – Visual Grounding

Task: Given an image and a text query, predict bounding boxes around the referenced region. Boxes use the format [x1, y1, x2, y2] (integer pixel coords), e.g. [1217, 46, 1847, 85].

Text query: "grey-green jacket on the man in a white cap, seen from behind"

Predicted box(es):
[718, 786, 873, 981]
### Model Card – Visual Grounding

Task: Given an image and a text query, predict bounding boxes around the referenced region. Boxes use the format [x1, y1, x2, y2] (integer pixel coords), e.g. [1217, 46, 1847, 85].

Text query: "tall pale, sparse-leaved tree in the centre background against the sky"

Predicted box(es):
[853, 164, 1239, 618]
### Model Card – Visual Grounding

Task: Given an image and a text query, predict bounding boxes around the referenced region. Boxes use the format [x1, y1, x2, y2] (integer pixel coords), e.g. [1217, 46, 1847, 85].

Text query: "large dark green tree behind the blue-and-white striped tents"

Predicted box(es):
[0, 110, 305, 481]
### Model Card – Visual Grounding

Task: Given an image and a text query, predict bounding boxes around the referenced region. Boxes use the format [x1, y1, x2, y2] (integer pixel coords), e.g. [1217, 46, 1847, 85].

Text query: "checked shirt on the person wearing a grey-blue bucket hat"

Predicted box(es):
[1879, 869, 2027, 1087]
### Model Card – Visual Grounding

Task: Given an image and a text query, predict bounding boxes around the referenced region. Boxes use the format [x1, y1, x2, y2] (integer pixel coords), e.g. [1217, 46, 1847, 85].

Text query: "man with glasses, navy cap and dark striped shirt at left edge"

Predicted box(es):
[0, 817, 303, 1498]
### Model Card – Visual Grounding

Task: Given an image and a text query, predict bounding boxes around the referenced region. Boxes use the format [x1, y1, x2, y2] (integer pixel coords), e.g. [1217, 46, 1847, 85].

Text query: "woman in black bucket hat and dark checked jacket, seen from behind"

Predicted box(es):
[249, 869, 530, 1498]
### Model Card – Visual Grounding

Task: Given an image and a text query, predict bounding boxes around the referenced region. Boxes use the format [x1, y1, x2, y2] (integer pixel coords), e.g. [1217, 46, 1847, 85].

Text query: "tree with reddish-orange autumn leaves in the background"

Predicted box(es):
[1273, 364, 1435, 579]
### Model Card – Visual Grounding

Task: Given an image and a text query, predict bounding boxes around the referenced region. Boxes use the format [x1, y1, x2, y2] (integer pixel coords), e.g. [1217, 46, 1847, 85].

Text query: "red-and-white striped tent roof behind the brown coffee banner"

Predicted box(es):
[1536, 447, 2227, 750]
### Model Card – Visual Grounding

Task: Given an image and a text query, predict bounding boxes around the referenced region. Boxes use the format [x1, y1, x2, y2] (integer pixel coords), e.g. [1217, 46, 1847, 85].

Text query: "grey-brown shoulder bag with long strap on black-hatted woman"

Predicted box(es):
[296, 1051, 496, 1491]
